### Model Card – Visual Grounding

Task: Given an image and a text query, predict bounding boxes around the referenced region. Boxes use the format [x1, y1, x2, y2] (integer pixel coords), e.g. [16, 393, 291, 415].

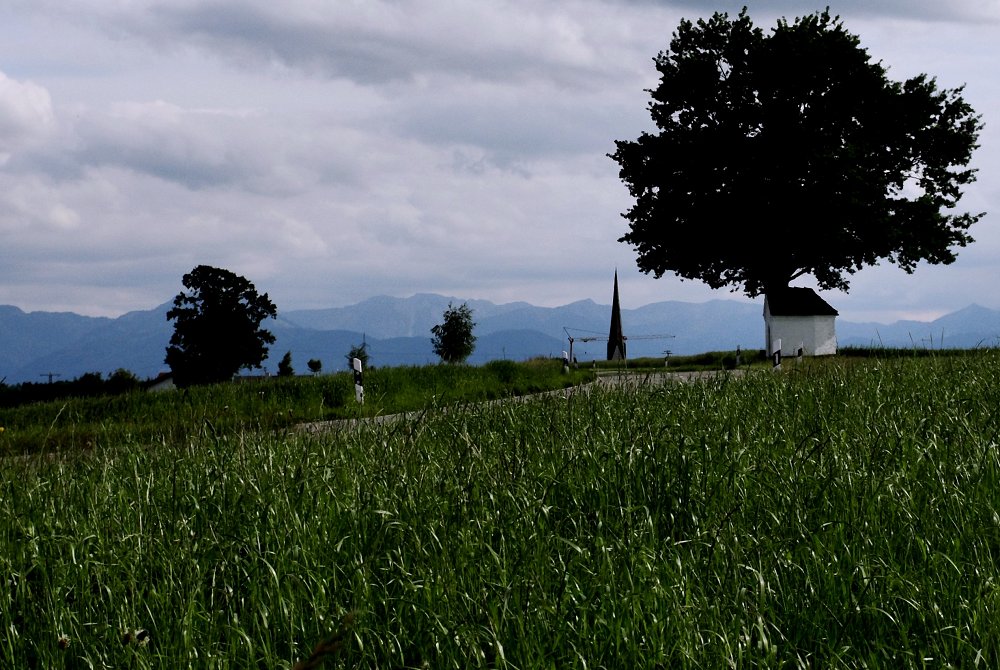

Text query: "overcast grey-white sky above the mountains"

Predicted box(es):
[0, 0, 1000, 322]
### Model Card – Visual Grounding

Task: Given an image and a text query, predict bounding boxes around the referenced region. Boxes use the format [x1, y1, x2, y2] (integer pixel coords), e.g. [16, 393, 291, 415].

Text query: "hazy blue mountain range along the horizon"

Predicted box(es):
[0, 294, 1000, 384]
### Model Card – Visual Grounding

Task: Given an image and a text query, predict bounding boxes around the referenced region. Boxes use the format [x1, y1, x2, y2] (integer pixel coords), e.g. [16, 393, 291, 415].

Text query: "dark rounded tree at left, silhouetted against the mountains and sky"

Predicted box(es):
[166, 265, 277, 387]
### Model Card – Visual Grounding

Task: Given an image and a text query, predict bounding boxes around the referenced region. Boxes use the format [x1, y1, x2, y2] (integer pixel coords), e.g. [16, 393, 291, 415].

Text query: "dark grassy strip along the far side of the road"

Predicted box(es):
[0, 359, 594, 455]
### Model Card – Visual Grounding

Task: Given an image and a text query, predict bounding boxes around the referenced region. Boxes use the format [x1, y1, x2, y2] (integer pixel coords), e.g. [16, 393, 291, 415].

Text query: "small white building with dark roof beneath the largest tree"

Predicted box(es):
[764, 287, 837, 356]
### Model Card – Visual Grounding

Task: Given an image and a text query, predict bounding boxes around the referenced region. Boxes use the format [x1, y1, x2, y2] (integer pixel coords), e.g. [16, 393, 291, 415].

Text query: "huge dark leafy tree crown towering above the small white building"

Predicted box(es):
[611, 9, 982, 297]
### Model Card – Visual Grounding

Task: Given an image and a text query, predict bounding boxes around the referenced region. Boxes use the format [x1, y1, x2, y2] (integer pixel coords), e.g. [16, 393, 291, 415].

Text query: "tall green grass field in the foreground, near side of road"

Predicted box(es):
[0, 352, 1000, 669]
